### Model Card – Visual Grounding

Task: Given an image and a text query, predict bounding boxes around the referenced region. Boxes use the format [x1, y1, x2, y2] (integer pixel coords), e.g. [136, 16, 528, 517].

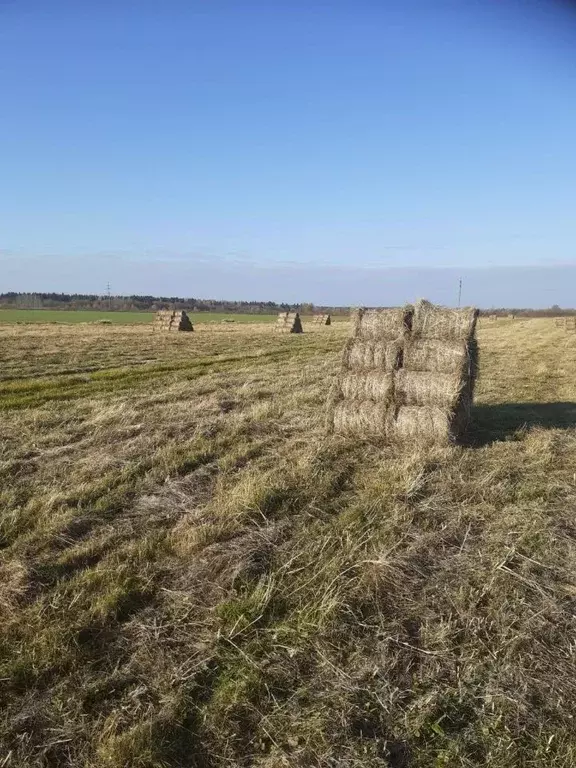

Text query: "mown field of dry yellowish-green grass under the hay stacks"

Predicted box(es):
[0, 313, 576, 768]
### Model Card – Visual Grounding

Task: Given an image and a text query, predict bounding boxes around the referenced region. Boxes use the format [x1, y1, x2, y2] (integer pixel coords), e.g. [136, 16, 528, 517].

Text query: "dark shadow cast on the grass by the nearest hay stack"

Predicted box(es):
[470, 402, 576, 446]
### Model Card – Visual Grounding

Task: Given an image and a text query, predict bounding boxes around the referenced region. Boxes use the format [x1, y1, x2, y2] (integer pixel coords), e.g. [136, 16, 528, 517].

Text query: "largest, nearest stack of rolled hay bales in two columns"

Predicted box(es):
[328, 301, 478, 444]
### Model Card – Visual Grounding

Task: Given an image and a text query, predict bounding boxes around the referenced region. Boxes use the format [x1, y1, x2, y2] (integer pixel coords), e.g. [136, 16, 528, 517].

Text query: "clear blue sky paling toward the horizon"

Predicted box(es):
[0, 0, 576, 306]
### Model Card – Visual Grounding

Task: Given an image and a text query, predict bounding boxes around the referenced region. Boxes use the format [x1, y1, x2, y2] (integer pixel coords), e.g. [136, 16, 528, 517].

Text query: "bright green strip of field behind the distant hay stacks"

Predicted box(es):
[0, 309, 277, 325]
